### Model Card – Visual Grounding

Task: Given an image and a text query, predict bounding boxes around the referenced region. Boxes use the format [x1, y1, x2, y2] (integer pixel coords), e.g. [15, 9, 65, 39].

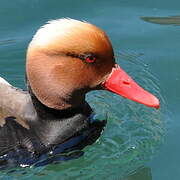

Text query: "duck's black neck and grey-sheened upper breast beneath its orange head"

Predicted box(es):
[25, 82, 92, 146]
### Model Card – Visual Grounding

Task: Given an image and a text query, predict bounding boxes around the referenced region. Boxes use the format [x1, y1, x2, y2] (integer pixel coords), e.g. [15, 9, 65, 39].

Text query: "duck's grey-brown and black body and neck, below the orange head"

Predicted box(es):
[0, 81, 106, 167]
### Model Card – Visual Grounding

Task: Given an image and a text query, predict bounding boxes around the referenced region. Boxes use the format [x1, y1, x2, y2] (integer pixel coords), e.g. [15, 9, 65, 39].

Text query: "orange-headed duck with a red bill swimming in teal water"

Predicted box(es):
[0, 18, 160, 166]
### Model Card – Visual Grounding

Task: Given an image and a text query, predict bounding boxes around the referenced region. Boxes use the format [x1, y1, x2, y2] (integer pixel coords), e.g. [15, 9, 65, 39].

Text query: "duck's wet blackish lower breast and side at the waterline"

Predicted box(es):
[0, 117, 106, 169]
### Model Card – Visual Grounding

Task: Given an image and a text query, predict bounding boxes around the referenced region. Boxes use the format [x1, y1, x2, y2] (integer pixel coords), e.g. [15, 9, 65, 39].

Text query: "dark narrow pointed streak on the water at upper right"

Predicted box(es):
[141, 16, 180, 25]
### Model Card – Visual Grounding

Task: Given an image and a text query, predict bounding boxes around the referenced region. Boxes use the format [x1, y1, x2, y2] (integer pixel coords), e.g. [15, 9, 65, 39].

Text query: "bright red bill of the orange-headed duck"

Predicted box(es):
[103, 65, 160, 109]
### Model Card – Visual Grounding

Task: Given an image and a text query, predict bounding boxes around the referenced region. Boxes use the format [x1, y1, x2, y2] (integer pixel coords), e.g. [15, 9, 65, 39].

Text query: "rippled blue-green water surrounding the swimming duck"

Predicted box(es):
[0, 0, 180, 180]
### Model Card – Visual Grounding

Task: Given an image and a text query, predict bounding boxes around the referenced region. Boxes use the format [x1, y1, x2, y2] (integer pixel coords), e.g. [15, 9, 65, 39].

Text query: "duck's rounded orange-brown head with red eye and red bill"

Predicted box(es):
[26, 19, 159, 110]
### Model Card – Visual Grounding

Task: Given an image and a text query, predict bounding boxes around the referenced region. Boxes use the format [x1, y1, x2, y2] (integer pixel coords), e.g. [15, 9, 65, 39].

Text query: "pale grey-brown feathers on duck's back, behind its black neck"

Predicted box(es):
[0, 78, 36, 128]
